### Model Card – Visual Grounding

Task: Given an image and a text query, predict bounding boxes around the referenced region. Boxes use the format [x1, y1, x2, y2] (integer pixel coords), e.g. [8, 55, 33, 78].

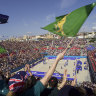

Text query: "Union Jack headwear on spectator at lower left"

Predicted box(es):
[9, 71, 28, 92]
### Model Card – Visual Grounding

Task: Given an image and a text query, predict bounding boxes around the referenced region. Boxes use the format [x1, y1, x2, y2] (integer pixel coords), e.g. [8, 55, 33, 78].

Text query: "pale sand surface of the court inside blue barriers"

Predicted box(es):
[14, 58, 91, 83]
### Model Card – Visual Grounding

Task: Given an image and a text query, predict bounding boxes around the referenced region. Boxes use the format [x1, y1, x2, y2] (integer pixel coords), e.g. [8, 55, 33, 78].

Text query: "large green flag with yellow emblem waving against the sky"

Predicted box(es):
[42, 2, 96, 37]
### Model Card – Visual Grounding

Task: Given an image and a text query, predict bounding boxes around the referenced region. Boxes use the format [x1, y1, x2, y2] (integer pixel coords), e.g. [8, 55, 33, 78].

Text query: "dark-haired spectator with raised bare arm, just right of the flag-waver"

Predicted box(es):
[40, 70, 67, 96]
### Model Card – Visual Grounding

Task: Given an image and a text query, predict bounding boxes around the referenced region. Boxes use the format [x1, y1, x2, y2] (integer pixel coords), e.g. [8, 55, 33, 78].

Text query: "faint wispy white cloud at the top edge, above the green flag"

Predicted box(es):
[60, 0, 77, 9]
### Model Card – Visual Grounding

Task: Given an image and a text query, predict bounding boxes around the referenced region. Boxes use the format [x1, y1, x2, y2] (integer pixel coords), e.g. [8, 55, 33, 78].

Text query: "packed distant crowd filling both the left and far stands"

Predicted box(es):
[0, 38, 87, 74]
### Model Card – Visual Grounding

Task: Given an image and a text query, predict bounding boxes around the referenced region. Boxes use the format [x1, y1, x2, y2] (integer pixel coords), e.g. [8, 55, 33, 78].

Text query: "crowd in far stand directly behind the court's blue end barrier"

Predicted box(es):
[46, 38, 87, 56]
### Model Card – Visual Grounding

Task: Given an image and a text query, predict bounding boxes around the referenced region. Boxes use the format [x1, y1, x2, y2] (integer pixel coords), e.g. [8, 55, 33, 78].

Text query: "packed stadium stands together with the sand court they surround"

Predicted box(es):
[0, 38, 96, 95]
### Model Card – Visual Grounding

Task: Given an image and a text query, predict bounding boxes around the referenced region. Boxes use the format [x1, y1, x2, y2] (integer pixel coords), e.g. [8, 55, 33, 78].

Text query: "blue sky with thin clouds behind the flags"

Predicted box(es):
[0, 0, 96, 39]
